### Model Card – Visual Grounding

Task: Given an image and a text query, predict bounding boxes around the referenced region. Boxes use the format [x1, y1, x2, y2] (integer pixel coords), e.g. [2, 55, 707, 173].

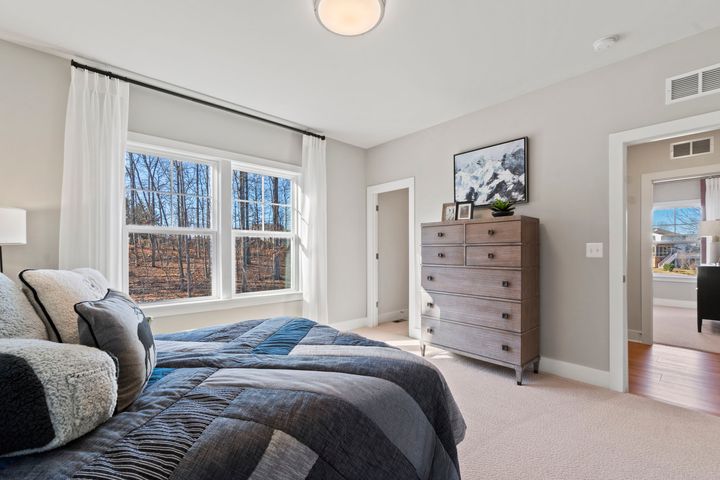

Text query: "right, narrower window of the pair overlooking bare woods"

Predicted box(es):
[232, 170, 295, 294]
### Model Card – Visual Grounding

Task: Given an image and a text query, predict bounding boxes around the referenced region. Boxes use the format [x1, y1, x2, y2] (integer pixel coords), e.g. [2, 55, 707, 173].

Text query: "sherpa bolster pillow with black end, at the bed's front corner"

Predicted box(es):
[0, 338, 117, 456]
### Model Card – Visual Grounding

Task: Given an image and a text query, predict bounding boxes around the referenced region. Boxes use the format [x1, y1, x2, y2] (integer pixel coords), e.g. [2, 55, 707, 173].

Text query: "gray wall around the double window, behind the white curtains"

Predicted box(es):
[0, 41, 366, 331]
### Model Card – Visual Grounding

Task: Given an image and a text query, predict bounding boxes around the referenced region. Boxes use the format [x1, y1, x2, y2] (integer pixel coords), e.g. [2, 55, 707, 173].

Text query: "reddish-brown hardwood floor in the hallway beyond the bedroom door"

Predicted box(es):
[628, 342, 720, 416]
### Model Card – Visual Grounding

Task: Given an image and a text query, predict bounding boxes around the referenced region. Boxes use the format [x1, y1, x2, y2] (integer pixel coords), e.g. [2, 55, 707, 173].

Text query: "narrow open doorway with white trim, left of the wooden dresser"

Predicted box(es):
[367, 178, 420, 338]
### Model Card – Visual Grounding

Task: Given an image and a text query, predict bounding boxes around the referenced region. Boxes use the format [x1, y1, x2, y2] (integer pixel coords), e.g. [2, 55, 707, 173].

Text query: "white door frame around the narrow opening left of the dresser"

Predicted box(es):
[367, 177, 420, 338]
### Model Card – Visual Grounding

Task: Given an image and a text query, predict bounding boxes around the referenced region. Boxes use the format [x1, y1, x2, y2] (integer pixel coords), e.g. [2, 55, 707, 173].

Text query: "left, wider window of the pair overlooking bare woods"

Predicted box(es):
[125, 151, 217, 303]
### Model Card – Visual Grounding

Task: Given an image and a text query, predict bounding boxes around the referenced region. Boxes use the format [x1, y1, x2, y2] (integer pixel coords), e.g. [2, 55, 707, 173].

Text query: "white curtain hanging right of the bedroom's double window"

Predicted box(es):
[299, 135, 328, 323]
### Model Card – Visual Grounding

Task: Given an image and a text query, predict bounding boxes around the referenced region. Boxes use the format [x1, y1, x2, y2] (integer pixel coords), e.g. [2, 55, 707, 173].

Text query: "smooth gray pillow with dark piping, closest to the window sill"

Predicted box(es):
[75, 290, 157, 412]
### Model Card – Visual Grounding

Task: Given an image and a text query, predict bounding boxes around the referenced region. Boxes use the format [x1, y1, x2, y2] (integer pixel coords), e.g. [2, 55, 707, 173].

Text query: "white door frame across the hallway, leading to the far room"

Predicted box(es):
[639, 165, 720, 345]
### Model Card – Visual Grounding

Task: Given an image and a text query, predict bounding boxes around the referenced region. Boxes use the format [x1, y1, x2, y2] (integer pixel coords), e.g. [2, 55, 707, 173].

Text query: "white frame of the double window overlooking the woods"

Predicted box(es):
[121, 132, 302, 317]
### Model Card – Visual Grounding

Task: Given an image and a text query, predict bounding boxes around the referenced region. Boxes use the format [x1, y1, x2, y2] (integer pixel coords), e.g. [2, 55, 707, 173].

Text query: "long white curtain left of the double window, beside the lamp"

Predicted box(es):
[59, 68, 130, 288]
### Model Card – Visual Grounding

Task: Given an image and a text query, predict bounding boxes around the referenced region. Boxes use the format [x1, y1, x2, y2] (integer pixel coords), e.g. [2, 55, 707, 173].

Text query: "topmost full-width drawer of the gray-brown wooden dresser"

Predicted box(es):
[422, 266, 523, 300]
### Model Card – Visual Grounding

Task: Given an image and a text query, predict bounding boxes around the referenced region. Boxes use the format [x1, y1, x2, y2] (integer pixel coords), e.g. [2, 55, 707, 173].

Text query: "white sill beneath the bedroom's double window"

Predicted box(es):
[140, 291, 302, 318]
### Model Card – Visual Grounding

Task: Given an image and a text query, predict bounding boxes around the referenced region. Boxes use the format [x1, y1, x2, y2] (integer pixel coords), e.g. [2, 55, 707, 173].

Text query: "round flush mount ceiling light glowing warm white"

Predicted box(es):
[314, 0, 385, 37]
